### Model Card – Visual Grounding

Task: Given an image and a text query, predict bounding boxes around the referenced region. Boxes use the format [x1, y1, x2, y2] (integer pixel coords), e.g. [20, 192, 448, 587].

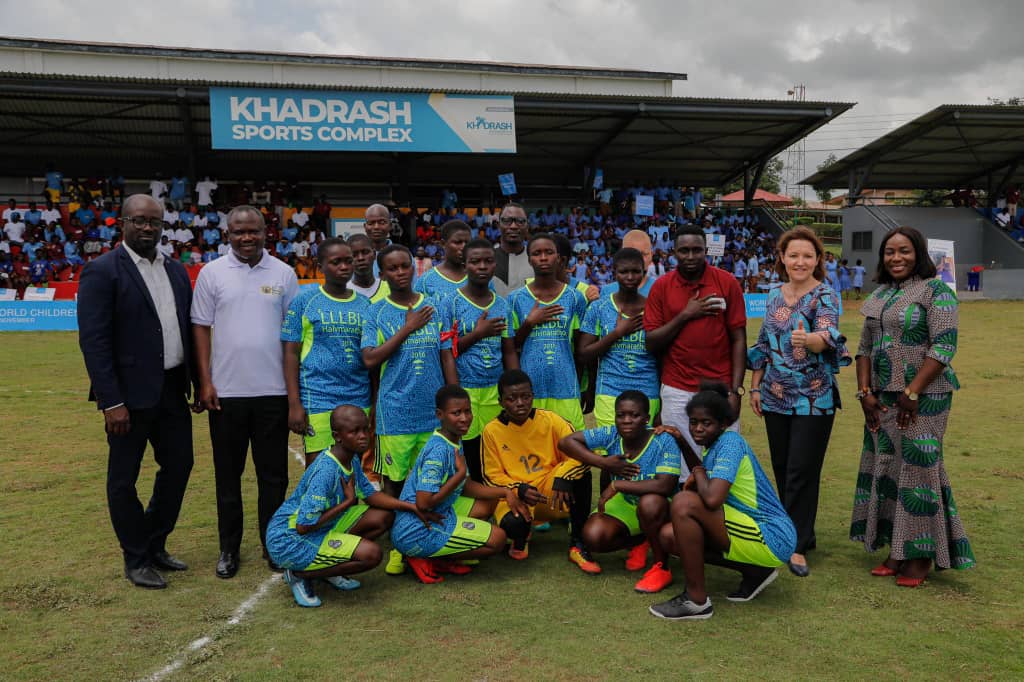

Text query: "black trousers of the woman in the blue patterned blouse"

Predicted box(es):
[765, 412, 836, 558]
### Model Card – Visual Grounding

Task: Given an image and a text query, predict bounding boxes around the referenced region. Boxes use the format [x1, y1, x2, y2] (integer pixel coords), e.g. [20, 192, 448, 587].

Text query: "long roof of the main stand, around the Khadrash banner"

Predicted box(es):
[0, 38, 853, 192]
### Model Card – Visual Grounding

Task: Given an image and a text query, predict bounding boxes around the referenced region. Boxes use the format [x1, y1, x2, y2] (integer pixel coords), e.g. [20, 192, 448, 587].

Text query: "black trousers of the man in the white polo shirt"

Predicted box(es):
[210, 395, 288, 553]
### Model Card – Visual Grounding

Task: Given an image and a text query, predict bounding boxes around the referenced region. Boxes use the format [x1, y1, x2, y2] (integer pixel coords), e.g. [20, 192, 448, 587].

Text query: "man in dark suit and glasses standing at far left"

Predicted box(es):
[78, 195, 195, 589]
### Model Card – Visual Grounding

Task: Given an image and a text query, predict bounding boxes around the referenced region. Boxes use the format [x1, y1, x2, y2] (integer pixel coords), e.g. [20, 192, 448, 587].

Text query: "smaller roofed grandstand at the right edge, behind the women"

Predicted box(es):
[803, 104, 1024, 299]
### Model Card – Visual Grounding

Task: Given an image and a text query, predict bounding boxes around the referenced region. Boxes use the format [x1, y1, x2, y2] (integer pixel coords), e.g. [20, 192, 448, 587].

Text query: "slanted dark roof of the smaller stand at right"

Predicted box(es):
[802, 104, 1024, 193]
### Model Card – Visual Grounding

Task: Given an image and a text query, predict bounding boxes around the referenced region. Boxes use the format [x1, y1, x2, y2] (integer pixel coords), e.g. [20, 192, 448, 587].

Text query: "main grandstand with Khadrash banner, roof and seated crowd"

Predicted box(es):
[0, 38, 852, 298]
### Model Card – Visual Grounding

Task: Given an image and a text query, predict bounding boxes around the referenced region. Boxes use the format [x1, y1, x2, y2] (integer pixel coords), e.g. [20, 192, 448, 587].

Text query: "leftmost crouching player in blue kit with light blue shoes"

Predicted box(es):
[266, 404, 439, 606]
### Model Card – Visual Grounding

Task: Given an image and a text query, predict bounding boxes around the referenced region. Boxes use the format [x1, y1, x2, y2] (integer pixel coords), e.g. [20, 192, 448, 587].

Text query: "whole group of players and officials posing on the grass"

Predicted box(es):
[79, 196, 973, 620]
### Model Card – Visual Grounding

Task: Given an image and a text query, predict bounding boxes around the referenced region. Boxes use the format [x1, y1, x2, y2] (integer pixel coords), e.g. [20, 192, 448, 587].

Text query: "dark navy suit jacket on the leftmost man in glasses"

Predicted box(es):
[78, 246, 195, 410]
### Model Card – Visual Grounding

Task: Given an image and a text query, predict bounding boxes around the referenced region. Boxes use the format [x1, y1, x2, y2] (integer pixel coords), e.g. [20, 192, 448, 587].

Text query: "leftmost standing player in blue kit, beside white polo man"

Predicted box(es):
[281, 237, 371, 467]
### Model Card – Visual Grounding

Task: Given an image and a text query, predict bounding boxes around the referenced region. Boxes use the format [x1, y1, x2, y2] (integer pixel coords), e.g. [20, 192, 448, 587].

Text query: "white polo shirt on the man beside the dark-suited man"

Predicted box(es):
[191, 250, 299, 397]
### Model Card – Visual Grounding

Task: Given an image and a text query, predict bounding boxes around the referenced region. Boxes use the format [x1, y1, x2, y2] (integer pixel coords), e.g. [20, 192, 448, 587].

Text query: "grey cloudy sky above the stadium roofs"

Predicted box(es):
[0, 0, 1024, 192]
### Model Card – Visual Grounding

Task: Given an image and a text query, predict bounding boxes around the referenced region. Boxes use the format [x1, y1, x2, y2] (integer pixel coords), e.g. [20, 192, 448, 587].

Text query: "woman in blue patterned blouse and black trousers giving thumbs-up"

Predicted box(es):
[746, 227, 850, 578]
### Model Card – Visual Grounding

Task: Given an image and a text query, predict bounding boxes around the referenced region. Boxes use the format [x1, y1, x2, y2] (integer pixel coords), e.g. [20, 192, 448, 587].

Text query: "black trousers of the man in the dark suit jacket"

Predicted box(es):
[106, 368, 193, 568]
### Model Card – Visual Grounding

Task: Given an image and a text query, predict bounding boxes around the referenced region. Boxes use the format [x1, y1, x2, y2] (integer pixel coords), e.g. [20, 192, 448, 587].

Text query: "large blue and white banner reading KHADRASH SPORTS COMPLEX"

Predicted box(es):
[210, 88, 516, 154]
